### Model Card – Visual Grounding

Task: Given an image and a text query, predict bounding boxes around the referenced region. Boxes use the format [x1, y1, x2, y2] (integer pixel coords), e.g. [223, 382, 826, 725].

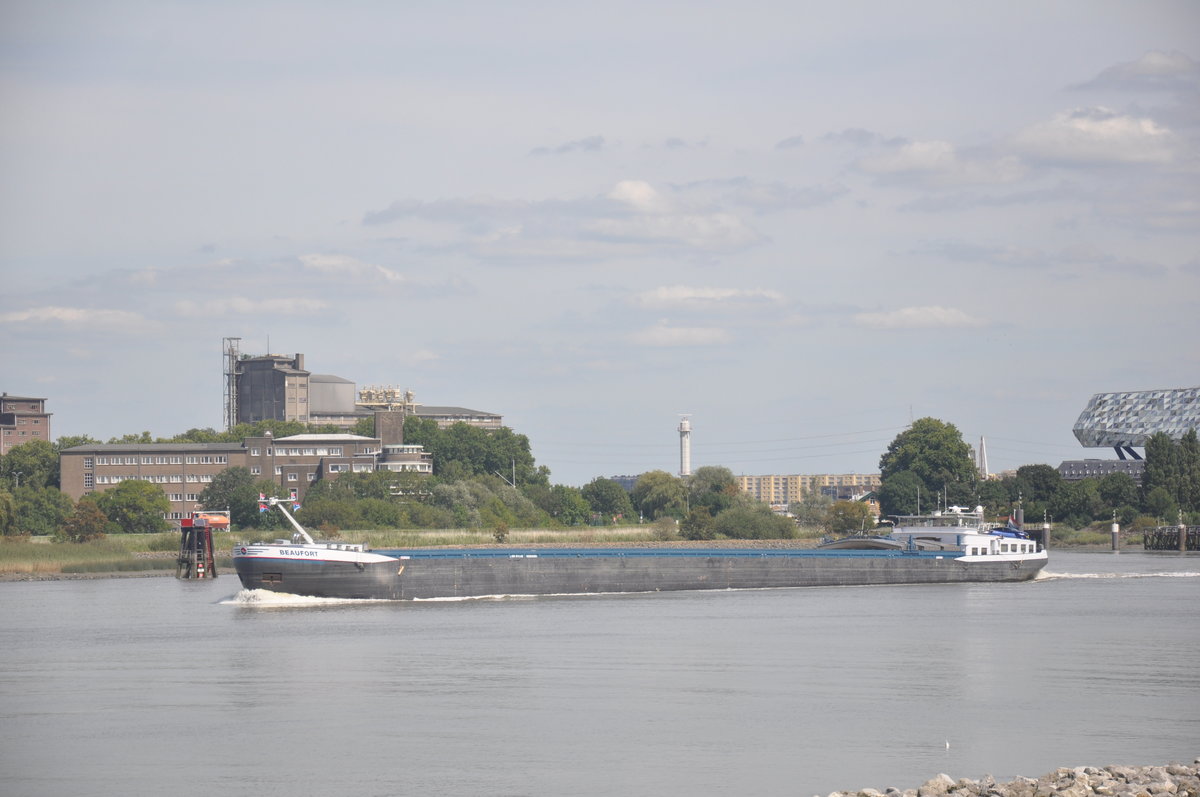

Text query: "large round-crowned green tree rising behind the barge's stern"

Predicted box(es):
[880, 418, 978, 508]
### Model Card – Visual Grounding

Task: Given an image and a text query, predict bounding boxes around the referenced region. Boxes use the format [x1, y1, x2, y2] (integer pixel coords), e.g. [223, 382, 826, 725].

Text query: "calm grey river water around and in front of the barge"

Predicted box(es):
[0, 552, 1200, 797]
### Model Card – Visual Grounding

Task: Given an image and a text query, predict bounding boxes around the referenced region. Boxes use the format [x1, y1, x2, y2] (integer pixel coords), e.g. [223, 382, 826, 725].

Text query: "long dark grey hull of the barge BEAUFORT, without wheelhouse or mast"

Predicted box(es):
[234, 549, 1046, 600]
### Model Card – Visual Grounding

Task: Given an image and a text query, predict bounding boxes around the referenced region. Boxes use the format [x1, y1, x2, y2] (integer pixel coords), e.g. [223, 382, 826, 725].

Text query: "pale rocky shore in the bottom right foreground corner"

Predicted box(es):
[817, 759, 1200, 797]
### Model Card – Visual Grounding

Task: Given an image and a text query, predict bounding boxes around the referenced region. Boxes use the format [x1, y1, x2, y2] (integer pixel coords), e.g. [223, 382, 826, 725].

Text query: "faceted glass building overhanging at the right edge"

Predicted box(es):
[1072, 388, 1200, 453]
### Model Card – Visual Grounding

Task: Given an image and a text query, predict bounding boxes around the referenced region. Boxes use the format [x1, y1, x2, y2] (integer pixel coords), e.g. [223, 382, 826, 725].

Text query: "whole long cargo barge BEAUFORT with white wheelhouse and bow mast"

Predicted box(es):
[233, 503, 1046, 600]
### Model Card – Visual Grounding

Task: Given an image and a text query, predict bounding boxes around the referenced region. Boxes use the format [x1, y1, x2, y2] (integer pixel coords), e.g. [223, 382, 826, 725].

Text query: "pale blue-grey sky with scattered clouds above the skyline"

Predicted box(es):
[0, 0, 1200, 485]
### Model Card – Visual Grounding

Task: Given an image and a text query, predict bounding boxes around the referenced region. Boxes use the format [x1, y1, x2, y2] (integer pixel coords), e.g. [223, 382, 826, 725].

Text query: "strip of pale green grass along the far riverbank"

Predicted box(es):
[0, 523, 1141, 581]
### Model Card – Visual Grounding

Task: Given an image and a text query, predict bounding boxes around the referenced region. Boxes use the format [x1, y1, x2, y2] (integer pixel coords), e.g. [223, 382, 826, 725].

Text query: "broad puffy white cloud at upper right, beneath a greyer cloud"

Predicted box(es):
[1014, 107, 1176, 164]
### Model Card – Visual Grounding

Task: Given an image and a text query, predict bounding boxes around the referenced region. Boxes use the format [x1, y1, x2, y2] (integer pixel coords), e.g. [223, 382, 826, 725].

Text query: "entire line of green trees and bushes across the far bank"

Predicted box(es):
[7, 418, 1200, 540]
